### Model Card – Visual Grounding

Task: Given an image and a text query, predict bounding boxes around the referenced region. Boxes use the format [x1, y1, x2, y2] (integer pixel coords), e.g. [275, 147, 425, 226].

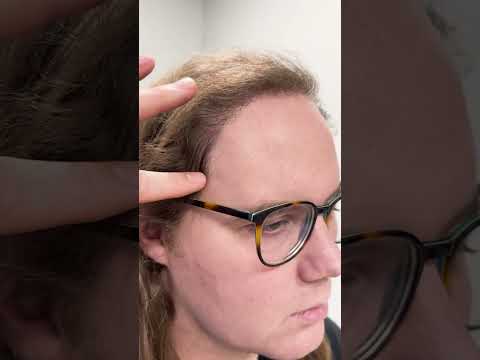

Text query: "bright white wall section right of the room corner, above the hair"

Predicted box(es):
[203, 0, 341, 143]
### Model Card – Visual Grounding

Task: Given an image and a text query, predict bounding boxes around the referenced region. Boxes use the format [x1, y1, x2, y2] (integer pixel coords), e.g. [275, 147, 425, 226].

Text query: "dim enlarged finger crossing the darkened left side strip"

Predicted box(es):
[0, 157, 138, 235]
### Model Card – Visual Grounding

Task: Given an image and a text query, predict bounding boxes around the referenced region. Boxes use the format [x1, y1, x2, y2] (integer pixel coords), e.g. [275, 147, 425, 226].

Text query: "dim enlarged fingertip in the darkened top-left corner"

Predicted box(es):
[0, 0, 102, 38]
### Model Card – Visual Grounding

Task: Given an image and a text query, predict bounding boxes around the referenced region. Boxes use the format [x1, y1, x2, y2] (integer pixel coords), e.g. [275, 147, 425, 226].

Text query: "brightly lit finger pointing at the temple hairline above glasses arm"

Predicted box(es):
[138, 170, 206, 204]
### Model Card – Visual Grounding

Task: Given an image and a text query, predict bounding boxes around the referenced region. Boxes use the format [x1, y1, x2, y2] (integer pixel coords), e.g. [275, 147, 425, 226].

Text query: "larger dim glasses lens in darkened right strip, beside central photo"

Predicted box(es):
[342, 235, 419, 358]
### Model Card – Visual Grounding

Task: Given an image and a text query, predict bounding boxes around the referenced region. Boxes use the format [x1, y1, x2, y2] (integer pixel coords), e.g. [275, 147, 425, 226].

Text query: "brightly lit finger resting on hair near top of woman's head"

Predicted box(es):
[139, 78, 197, 121]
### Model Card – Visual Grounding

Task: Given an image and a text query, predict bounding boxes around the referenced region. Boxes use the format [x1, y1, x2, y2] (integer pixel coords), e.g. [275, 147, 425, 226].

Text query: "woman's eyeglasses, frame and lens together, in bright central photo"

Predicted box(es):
[182, 188, 342, 267]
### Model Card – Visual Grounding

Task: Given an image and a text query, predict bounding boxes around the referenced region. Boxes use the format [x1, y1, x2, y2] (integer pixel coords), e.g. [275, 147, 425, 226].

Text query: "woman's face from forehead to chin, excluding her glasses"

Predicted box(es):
[165, 95, 340, 359]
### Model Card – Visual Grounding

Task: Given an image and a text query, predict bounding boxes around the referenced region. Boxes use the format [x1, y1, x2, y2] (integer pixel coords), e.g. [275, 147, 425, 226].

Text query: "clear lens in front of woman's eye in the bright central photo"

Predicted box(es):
[260, 204, 315, 265]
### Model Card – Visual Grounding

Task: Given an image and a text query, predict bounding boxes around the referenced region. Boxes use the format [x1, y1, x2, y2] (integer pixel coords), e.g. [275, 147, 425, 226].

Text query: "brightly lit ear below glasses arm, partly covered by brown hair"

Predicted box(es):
[140, 218, 168, 266]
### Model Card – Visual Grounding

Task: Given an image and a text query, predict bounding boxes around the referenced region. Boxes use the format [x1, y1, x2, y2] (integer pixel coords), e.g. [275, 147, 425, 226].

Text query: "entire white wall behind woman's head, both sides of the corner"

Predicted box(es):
[140, 0, 341, 324]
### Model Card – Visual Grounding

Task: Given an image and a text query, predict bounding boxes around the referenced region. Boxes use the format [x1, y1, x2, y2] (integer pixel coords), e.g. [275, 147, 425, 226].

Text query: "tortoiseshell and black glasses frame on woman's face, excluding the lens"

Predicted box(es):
[181, 188, 342, 267]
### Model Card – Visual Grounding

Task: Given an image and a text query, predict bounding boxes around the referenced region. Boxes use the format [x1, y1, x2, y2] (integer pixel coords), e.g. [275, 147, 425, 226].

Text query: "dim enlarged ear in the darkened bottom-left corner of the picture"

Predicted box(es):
[0, 279, 69, 360]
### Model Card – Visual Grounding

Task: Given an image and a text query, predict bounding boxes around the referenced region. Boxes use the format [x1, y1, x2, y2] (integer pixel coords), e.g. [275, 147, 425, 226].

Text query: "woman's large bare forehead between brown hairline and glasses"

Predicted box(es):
[201, 95, 339, 208]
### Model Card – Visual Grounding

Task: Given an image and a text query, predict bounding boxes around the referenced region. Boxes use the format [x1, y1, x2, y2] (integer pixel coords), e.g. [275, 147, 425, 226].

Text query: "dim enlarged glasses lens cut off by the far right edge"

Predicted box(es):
[446, 226, 480, 348]
